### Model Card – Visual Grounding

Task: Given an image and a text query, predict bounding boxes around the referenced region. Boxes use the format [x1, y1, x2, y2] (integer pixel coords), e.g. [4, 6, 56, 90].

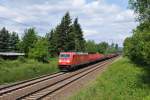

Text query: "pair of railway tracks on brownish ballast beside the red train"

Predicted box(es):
[0, 58, 118, 100]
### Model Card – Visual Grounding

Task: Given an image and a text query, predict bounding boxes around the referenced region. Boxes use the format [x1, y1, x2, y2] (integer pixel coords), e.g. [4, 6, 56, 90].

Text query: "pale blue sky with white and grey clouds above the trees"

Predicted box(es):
[0, 0, 137, 46]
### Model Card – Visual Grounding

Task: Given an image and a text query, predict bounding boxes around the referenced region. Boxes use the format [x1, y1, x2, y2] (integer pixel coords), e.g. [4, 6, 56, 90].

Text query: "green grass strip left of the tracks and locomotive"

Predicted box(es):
[0, 58, 58, 85]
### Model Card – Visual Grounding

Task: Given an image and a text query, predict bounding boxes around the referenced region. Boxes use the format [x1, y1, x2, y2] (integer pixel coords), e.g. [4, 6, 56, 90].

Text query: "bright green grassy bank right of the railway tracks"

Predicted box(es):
[69, 58, 150, 100]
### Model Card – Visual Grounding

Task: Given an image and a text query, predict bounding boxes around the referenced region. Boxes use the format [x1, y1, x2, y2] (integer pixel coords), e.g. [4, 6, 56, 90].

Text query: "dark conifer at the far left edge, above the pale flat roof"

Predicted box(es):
[0, 27, 10, 52]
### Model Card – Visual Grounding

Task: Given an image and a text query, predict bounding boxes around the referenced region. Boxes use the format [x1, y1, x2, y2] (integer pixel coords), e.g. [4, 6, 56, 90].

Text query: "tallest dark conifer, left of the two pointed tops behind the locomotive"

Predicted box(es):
[51, 12, 71, 54]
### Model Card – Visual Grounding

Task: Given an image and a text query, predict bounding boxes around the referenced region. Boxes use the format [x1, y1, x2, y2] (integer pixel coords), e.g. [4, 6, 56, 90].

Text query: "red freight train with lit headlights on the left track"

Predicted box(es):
[58, 52, 117, 71]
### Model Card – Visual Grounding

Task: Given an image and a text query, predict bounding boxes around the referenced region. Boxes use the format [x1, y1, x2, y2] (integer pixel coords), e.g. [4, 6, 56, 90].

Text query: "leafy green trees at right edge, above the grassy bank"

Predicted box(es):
[124, 0, 150, 65]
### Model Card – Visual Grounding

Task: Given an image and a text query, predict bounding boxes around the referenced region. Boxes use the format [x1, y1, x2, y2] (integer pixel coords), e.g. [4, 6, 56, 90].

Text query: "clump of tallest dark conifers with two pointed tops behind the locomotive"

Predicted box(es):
[47, 12, 85, 55]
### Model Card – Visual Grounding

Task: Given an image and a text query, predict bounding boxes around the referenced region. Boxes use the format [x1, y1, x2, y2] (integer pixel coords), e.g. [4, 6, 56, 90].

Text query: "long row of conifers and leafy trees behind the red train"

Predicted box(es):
[0, 12, 119, 61]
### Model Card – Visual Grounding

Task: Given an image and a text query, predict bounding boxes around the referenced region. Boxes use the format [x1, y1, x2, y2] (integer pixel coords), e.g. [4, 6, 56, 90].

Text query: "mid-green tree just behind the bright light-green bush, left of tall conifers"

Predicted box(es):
[22, 28, 37, 56]
